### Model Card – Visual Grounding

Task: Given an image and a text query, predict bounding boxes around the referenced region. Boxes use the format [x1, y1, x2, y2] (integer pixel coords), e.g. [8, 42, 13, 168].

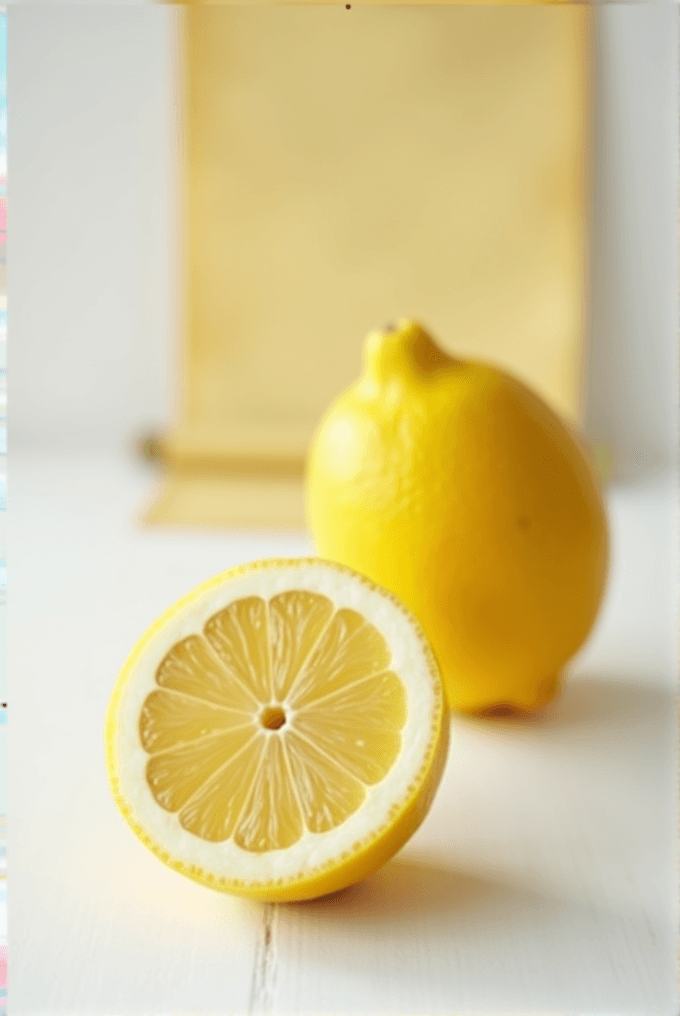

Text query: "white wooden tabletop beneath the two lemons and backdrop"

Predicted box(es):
[8, 449, 677, 1016]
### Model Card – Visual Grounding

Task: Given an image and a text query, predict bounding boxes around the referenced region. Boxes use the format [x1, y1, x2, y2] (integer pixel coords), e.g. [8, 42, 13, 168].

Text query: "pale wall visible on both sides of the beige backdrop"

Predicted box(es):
[8, 4, 678, 474]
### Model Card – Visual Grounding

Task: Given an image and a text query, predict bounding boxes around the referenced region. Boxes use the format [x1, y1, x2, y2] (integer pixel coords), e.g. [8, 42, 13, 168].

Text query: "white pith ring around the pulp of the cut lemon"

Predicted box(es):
[113, 561, 441, 883]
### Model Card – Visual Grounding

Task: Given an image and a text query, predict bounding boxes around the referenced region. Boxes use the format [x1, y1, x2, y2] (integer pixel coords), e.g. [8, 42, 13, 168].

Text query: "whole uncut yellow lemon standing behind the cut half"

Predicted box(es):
[306, 321, 608, 713]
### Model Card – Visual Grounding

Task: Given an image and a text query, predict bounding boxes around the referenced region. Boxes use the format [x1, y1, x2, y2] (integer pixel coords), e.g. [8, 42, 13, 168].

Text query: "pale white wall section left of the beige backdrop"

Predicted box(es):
[7, 5, 176, 444]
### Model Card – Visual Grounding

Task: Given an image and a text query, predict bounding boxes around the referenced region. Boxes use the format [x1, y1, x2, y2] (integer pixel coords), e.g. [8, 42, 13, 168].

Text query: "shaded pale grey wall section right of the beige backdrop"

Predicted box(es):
[585, 5, 678, 477]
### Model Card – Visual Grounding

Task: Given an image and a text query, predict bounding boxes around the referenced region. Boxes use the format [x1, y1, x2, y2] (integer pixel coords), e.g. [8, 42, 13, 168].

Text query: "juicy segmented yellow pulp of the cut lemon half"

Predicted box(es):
[139, 590, 406, 851]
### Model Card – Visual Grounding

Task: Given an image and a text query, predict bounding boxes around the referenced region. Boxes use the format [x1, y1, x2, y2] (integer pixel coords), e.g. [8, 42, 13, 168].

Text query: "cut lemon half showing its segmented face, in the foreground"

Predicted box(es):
[106, 559, 448, 901]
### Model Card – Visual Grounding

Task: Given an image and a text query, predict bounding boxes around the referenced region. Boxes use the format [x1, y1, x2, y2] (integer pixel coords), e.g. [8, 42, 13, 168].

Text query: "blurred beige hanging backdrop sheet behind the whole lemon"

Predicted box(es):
[150, 5, 589, 525]
